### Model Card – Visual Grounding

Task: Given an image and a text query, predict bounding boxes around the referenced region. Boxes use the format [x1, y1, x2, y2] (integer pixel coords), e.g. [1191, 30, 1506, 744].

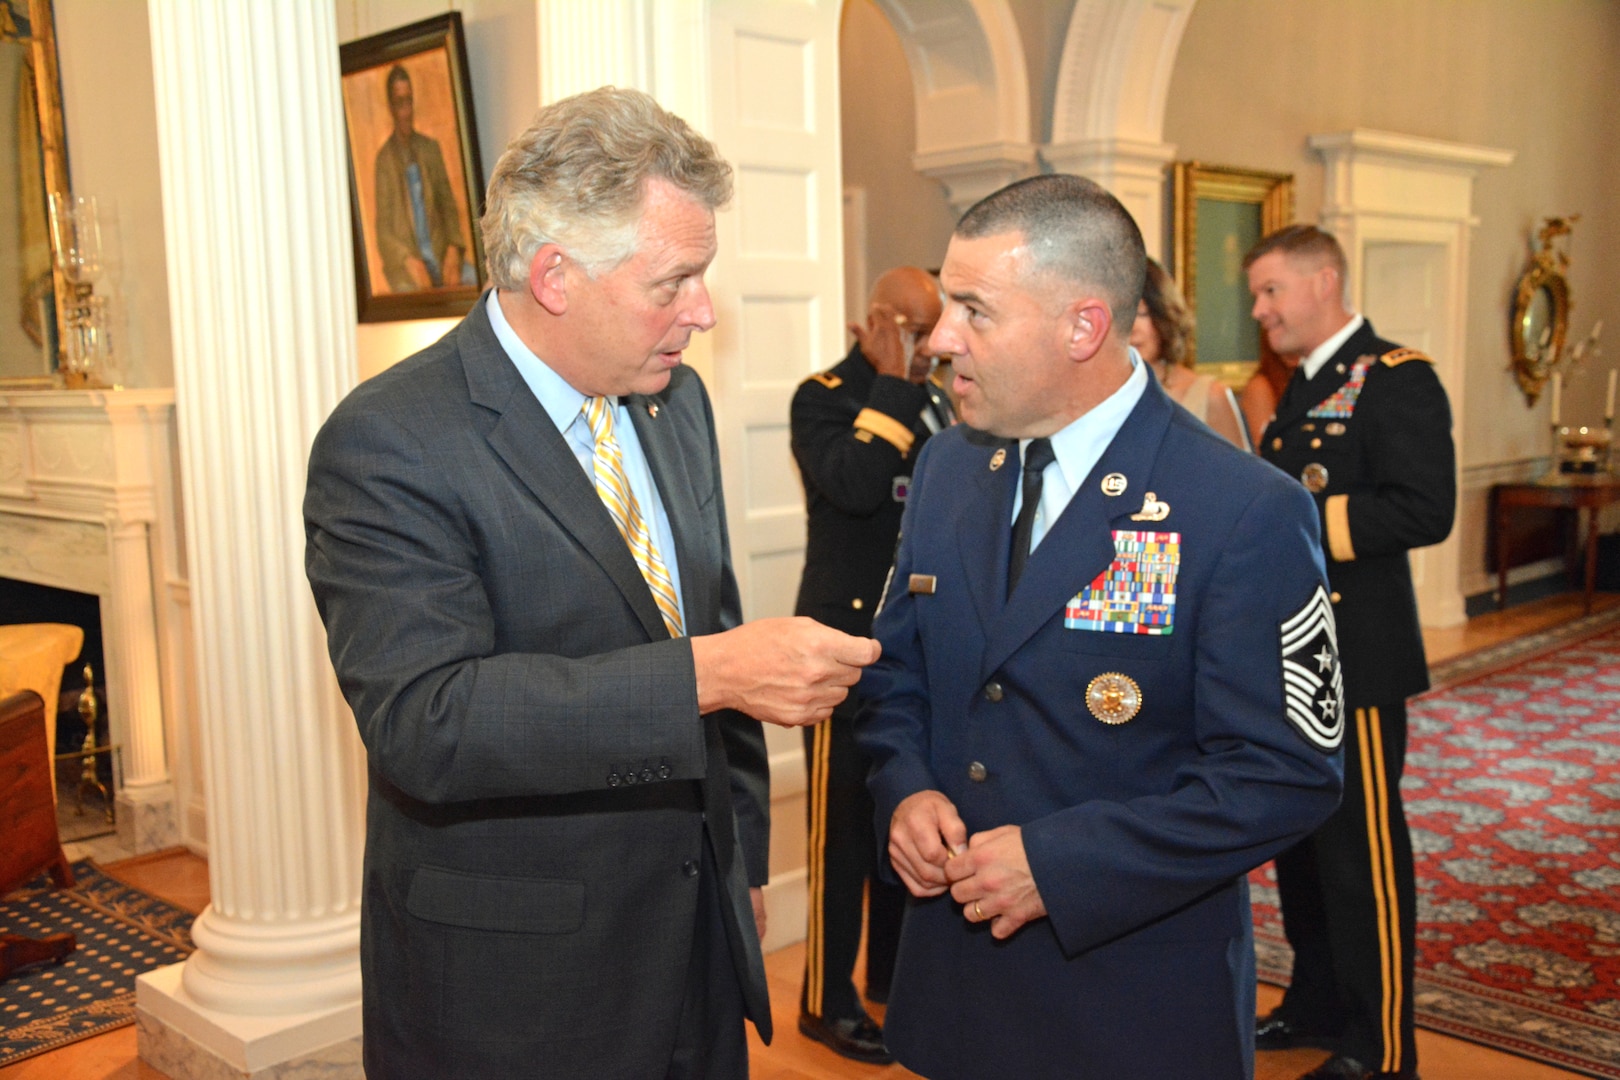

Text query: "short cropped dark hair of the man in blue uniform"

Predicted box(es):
[956, 173, 1147, 335]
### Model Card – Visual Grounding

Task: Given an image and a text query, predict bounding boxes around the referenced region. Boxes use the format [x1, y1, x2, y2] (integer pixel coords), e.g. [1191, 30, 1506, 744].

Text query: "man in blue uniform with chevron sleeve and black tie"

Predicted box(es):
[859, 175, 1343, 1080]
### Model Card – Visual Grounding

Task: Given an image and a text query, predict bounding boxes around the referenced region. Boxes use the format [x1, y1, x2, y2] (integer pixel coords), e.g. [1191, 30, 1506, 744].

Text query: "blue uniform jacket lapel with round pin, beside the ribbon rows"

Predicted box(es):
[982, 379, 1175, 678]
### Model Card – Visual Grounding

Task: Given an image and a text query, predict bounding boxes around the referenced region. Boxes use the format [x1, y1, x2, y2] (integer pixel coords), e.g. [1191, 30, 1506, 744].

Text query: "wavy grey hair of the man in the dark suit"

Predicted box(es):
[483, 86, 731, 288]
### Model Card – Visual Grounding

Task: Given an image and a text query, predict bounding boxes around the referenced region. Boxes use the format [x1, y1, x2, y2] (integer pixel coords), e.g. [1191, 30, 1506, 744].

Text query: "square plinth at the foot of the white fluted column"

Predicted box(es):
[134, 963, 365, 1080]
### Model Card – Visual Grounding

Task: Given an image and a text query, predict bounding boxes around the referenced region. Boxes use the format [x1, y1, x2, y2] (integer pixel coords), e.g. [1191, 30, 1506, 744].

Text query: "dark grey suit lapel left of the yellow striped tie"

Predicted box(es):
[457, 300, 669, 641]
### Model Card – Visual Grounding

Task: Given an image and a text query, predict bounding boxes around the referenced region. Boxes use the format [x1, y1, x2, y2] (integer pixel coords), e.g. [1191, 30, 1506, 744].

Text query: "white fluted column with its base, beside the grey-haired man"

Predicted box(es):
[138, 0, 365, 1077]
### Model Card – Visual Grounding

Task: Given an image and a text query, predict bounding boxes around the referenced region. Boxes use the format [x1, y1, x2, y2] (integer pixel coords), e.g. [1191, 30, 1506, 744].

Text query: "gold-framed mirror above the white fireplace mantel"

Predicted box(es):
[0, 0, 68, 389]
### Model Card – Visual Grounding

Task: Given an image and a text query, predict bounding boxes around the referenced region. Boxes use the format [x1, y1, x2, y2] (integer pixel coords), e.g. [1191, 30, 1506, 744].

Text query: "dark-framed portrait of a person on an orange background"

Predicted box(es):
[340, 11, 484, 322]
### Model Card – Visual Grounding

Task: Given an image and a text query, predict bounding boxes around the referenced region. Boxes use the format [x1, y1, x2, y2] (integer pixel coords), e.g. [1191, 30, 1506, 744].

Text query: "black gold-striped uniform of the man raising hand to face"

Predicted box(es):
[792, 345, 951, 1018]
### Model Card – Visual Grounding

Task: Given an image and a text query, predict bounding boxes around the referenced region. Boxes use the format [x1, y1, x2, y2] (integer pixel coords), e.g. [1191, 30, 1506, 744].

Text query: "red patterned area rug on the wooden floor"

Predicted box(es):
[1251, 628, 1620, 1080]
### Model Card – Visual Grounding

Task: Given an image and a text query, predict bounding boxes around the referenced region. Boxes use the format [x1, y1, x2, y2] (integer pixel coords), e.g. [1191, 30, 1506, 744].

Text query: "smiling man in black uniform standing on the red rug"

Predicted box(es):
[1244, 225, 1456, 1080]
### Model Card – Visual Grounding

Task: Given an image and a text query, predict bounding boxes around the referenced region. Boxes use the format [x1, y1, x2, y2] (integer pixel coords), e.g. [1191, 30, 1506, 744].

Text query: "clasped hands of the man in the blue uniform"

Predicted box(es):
[889, 790, 1047, 941]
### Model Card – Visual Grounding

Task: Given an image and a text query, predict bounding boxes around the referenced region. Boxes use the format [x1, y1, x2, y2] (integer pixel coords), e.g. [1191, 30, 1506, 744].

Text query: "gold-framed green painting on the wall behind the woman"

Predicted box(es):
[1173, 162, 1294, 385]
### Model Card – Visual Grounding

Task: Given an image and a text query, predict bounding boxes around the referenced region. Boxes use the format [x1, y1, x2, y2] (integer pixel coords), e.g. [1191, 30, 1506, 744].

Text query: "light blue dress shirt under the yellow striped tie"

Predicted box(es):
[486, 290, 687, 627]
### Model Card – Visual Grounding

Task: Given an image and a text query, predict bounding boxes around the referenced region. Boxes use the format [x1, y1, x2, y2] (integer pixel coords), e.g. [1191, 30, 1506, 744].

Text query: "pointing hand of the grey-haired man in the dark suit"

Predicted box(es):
[692, 615, 883, 727]
